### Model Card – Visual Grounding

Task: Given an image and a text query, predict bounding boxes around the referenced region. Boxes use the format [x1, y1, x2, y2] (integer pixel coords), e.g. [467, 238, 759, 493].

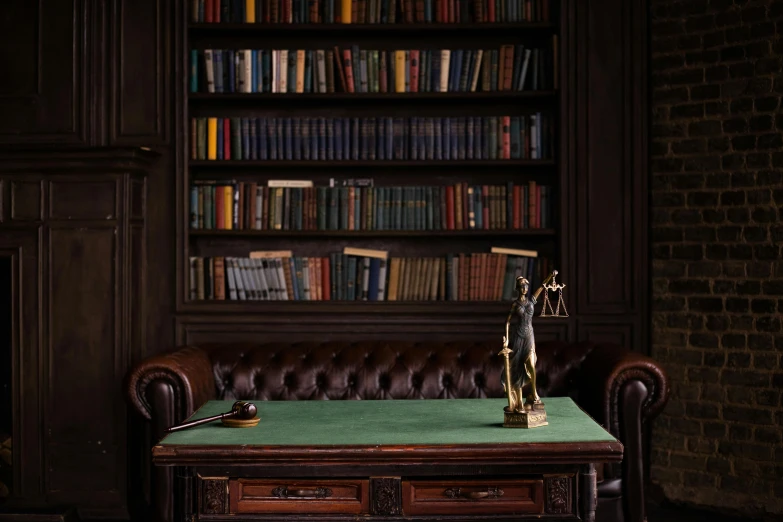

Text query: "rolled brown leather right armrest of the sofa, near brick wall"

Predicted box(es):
[579, 344, 669, 434]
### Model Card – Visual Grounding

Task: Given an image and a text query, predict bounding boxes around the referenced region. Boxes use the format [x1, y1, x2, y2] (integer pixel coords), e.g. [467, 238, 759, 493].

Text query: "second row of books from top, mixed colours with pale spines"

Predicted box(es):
[190, 42, 557, 93]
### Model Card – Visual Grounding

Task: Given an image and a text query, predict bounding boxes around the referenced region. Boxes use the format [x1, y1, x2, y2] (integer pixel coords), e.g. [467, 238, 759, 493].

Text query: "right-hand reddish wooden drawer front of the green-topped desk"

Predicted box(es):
[402, 479, 544, 516]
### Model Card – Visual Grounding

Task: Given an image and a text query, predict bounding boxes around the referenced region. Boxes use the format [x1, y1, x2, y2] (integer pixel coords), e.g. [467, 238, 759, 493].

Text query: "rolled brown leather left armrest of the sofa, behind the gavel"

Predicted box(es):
[126, 346, 215, 422]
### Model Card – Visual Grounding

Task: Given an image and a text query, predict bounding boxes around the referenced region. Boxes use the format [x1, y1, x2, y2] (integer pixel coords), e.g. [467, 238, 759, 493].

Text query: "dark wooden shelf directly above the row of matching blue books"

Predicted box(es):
[188, 90, 556, 104]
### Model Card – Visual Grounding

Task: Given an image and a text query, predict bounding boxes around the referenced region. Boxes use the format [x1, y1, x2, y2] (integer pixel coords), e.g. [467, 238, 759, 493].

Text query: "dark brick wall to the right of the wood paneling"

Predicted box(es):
[650, 0, 783, 515]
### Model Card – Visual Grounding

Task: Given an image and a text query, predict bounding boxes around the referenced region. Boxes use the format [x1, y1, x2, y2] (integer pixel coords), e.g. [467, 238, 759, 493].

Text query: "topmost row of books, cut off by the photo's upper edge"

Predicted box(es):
[190, 0, 550, 24]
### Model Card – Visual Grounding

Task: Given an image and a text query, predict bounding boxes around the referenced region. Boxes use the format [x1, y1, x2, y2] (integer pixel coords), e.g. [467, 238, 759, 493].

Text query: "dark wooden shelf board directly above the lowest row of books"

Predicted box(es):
[188, 228, 556, 238]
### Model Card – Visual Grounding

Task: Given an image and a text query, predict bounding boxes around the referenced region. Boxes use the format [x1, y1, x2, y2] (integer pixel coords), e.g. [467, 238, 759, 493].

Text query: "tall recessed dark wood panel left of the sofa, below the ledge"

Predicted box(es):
[44, 226, 118, 505]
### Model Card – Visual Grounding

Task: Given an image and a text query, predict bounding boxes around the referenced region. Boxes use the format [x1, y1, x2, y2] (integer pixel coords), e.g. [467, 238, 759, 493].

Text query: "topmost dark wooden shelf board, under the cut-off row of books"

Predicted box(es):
[188, 22, 556, 36]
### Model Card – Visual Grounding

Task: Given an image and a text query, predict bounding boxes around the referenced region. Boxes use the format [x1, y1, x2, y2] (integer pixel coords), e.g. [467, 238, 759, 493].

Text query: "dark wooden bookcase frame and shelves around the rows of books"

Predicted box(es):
[177, 0, 570, 319]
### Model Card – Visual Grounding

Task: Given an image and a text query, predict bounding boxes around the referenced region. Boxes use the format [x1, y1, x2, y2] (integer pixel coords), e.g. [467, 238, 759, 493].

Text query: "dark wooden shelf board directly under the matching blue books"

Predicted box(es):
[188, 159, 555, 169]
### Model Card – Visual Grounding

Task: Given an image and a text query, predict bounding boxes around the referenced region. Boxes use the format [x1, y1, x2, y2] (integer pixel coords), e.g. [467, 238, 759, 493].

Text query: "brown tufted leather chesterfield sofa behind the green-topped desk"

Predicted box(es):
[127, 341, 668, 522]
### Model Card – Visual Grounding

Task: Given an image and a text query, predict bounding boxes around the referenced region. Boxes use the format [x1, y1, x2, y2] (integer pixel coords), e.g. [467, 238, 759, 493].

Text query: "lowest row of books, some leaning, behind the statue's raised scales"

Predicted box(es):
[189, 247, 549, 301]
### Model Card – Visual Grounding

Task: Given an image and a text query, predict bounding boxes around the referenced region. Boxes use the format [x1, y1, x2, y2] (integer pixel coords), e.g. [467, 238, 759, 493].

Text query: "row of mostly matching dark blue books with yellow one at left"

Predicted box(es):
[190, 112, 553, 161]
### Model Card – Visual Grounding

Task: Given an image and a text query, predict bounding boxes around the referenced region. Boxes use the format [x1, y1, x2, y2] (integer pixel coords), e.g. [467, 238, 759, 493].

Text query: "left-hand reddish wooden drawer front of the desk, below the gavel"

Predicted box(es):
[229, 479, 370, 515]
